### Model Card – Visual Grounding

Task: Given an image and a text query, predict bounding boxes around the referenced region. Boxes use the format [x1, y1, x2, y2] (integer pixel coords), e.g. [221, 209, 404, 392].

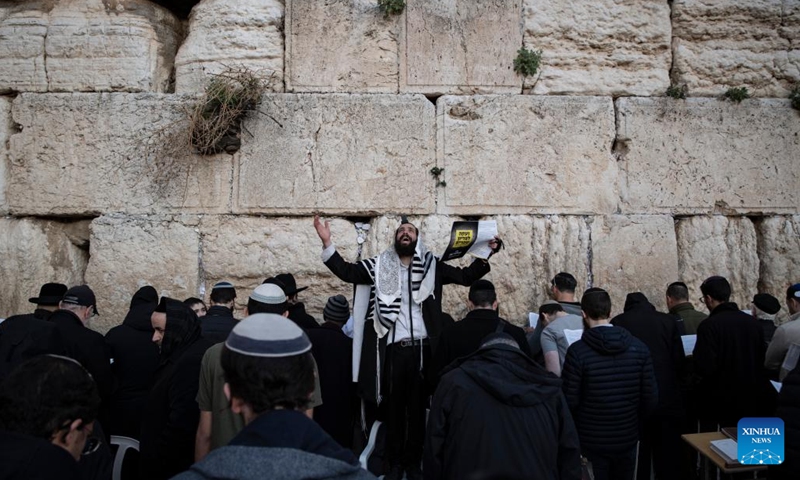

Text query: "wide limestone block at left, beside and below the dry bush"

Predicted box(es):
[7, 93, 233, 215]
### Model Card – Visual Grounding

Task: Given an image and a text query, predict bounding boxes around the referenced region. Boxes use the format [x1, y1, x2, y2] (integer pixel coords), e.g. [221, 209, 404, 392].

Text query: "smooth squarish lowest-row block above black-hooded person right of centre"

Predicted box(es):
[591, 215, 678, 315]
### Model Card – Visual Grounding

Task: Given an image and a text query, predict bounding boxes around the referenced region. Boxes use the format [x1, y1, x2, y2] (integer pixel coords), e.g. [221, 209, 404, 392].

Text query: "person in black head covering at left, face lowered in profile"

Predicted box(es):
[140, 297, 211, 479]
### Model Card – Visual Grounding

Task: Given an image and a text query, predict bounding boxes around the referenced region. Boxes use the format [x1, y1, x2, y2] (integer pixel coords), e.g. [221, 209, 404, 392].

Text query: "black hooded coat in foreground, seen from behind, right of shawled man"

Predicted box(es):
[423, 345, 581, 480]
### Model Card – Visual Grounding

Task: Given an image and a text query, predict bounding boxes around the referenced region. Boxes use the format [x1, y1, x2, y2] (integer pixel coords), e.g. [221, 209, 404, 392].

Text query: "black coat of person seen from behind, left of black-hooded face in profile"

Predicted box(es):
[106, 304, 159, 439]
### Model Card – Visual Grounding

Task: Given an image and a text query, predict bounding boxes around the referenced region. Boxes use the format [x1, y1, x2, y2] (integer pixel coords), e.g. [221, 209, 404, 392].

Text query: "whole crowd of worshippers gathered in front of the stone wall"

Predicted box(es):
[0, 218, 800, 480]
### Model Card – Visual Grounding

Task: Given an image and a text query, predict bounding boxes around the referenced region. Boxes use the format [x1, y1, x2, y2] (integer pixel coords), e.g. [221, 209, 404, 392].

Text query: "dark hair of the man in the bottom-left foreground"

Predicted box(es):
[0, 355, 100, 440]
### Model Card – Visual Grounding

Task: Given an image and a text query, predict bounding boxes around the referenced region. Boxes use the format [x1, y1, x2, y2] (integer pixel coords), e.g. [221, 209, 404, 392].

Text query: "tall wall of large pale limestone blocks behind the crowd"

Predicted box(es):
[0, 0, 800, 331]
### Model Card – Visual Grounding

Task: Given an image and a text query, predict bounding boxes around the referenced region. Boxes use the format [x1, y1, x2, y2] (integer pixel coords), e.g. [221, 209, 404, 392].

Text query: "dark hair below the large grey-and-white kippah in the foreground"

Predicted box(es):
[221, 345, 314, 414]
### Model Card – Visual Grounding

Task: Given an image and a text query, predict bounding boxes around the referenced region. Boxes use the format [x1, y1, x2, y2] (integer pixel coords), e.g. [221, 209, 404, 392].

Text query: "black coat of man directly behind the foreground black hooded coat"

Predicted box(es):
[430, 308, 531, 386]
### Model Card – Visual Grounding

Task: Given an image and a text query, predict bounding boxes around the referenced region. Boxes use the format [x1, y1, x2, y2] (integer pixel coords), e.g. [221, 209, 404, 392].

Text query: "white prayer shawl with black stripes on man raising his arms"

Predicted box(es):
[353, 238, 436, 401]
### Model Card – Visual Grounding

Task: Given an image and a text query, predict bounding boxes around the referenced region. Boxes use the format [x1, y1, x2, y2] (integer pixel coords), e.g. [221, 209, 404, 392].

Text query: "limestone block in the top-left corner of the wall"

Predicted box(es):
[0, 1, 49, 93]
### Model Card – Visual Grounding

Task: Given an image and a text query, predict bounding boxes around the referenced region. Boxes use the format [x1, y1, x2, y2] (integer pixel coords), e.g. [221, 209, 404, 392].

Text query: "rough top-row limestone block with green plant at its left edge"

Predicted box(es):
[523, 0, 672, 96]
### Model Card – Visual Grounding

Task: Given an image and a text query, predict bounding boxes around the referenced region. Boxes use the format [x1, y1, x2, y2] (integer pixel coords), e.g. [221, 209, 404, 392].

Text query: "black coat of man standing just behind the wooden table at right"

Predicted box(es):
[694, 302, 774, 427]
